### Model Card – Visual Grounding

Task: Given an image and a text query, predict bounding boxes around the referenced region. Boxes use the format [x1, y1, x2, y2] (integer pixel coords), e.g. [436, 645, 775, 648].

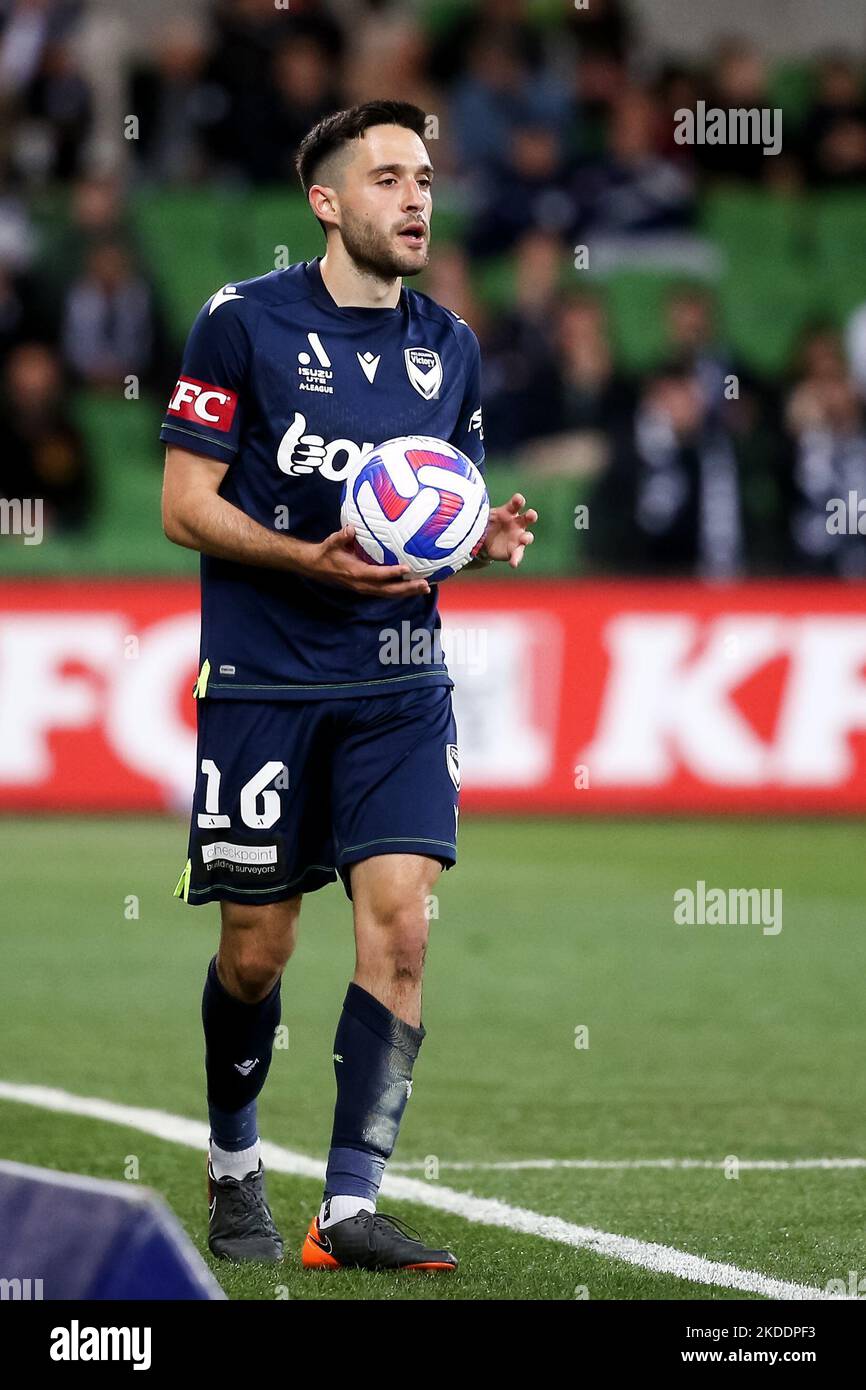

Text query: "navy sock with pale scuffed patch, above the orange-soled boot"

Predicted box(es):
[325, 984, 425, 1202]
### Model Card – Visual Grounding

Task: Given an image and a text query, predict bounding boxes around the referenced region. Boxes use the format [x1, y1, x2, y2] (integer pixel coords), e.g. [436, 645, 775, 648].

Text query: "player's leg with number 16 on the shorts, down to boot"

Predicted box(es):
[178, 701, 335, 1261]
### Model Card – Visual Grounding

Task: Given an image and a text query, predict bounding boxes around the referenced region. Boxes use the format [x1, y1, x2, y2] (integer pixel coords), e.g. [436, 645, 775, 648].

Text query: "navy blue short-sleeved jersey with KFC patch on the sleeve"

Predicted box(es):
[160, 259, 484, 699]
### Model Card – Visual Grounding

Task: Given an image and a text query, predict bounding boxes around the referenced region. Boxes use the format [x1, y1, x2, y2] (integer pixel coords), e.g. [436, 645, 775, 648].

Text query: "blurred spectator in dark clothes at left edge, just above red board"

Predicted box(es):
[0, 343, 93, 531]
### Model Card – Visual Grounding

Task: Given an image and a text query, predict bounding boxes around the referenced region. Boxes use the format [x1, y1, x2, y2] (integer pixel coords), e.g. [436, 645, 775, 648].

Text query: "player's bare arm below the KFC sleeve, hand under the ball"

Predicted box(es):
[163, 445, 430, 598]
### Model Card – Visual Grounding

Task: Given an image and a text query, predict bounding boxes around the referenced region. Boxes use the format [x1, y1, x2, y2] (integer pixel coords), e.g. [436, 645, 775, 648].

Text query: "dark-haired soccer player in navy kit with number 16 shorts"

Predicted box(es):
[160, 101, 537, 1270]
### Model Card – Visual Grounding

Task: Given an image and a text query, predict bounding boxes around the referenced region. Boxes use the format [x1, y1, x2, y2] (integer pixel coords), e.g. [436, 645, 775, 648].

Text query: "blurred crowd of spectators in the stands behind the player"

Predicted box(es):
[0, 0, 866, 578]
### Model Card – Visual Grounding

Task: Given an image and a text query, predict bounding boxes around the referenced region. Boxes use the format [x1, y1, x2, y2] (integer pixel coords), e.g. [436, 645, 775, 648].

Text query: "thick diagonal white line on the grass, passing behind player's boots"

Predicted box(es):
[0, 1081, 855, 1301]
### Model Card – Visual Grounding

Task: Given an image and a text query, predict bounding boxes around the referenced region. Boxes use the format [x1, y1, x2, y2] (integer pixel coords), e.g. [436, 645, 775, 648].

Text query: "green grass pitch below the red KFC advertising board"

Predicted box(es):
[0, 816, 866, 1300]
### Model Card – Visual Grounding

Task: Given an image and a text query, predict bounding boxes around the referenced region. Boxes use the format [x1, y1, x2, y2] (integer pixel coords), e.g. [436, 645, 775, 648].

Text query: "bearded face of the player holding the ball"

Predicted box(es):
[339, 125, 432, 279]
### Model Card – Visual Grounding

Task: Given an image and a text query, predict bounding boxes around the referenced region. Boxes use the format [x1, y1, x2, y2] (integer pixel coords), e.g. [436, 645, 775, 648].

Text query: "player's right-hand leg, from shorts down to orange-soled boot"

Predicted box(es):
[303, 689, 459, 1269]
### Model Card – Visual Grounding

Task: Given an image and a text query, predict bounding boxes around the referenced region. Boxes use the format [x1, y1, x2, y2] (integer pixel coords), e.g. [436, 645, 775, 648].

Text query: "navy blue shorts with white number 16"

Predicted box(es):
[177, 687, 460, 904]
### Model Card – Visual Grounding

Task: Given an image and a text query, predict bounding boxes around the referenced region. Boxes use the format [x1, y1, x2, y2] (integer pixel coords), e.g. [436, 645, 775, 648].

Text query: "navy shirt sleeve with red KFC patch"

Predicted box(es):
[160, 285, 252, 463]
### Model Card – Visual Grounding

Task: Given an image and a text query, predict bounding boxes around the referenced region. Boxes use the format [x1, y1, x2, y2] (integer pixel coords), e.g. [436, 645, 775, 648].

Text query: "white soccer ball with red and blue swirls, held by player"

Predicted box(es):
[341, 435, 491, 584]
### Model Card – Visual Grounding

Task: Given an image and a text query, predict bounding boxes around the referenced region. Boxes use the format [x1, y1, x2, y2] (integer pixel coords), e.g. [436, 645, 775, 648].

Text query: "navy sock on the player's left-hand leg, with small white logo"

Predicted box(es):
[202, 956, 279, 1152]
